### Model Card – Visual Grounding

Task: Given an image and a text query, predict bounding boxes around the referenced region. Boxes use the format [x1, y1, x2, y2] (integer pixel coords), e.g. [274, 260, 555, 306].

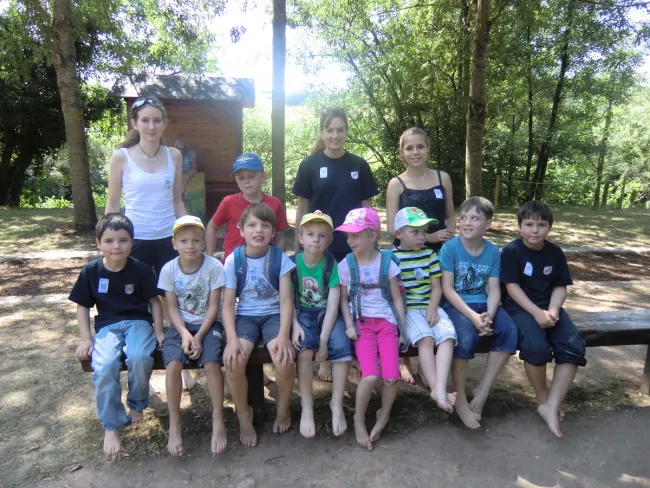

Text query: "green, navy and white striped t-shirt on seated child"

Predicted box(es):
[393, 247, 442, 308]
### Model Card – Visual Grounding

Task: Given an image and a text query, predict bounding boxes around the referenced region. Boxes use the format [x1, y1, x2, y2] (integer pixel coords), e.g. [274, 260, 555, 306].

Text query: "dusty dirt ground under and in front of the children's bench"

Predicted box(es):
[0, 282, 650, 488]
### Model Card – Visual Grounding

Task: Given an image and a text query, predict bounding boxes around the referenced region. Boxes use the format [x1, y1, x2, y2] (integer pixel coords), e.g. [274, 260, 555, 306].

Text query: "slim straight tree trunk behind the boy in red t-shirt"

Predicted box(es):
[271, 0, 287, 205]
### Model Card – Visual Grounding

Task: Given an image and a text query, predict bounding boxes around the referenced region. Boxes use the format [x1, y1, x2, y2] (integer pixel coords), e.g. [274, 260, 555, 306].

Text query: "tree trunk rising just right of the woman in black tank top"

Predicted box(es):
[465, 0, 490, 198]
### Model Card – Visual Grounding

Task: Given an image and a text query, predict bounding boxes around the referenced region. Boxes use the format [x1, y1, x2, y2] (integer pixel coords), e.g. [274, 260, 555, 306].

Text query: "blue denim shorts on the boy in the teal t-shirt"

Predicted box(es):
[442, 302, 517, 359]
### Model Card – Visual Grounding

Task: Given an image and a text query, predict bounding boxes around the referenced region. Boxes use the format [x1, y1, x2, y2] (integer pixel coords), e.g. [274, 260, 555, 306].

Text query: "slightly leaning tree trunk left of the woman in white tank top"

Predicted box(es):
[52, 0, 97, 230]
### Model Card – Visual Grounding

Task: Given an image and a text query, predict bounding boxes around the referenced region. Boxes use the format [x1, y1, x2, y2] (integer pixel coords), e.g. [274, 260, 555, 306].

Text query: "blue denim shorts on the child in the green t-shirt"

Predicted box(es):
[298, 307, 352, 362]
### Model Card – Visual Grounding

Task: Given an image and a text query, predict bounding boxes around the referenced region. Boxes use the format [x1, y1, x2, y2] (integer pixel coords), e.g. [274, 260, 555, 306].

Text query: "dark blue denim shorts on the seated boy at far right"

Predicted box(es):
[508, 307, 587, 366]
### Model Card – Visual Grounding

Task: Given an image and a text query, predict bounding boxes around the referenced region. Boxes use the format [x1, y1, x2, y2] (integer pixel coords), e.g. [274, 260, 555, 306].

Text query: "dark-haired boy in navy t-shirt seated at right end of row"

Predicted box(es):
[501, 200, 587, 437]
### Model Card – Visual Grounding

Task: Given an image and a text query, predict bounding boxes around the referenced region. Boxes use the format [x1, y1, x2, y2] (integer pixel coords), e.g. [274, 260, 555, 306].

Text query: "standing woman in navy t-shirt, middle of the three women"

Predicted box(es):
[293, 109, 379, 261]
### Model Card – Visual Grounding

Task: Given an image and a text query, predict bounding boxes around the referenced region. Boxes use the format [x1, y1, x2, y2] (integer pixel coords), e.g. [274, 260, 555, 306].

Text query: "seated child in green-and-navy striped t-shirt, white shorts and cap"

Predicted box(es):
[393, 207, 456, 413]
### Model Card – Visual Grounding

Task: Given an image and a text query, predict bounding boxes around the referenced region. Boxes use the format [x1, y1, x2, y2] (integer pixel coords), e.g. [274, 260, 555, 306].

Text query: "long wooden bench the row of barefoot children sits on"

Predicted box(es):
[81, 310, 650, 419]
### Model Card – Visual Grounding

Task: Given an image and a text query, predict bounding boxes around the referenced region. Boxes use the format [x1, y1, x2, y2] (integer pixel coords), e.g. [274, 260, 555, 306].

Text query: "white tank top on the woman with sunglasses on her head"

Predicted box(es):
[122, 146, 176, 241]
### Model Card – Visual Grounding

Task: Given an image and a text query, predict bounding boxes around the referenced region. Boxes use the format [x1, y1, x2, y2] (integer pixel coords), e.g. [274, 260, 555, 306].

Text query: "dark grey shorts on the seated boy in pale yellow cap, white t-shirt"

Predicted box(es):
[163, 322, 224, 367]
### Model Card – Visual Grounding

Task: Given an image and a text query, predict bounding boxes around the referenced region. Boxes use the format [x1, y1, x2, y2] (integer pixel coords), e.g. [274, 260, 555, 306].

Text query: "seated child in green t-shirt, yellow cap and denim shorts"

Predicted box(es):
[292, 210, 352, 438]
